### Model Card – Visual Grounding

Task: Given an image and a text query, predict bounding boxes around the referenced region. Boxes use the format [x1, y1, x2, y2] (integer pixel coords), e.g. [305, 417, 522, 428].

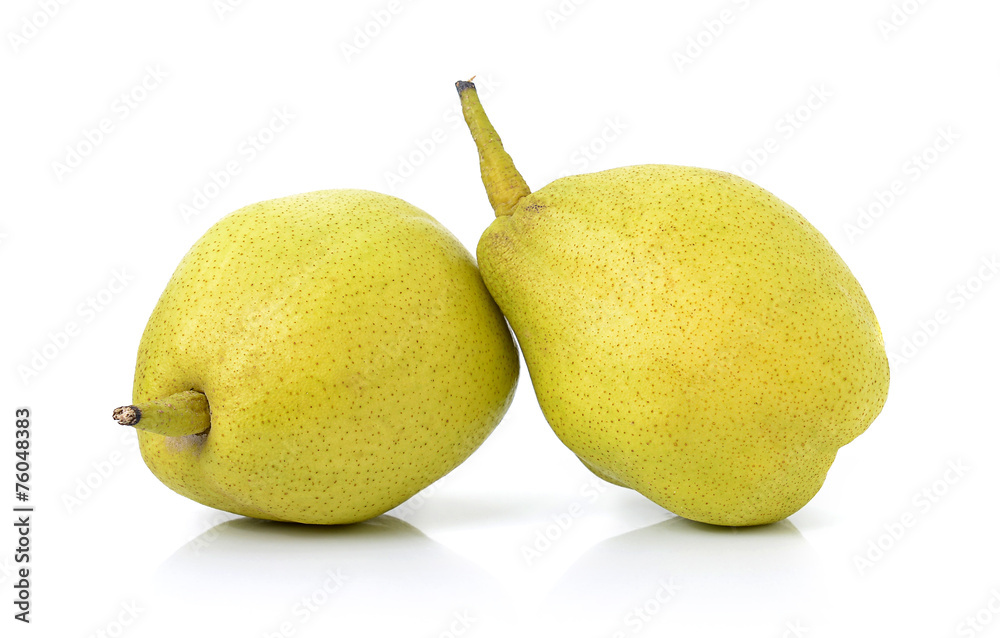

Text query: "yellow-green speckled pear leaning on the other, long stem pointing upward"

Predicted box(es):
[458, 82, 889, 525]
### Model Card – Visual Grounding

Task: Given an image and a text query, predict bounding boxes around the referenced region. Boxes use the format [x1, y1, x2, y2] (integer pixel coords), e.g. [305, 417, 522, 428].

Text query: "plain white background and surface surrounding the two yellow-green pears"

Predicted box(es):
[0, 0, 1000, 638]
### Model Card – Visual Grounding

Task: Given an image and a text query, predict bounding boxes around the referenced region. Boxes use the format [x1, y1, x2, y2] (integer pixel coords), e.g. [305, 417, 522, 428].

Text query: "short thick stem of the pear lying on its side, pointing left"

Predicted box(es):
[111, 390, 212, 436]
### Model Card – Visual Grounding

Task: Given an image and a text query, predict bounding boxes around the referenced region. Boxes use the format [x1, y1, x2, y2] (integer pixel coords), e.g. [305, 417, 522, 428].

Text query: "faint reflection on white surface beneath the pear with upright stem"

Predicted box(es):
[542, 517, 825, 637]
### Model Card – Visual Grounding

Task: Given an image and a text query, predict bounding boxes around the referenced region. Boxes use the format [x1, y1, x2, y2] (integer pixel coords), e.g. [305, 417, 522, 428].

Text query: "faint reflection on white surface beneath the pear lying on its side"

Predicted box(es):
[153, 515, 508, 637]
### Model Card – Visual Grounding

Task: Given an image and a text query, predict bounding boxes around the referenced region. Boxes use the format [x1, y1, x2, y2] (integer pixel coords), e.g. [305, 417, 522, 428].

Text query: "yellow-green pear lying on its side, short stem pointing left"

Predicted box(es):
[116, 190, 518, 523]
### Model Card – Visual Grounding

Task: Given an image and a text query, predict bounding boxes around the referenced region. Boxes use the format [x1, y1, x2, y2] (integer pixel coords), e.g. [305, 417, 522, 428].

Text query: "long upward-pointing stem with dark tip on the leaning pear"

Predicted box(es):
[455, 80, 531, 217]
